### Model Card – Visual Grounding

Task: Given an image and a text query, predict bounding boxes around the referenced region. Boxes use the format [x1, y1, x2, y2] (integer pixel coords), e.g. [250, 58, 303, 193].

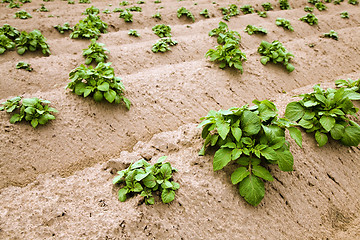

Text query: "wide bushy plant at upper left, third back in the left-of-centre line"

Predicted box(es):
[70, 14, 108, 39]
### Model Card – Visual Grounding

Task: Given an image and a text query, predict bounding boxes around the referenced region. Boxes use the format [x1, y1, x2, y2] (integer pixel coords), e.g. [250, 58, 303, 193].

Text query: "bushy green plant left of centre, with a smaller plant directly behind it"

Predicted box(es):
[67, 62, 131, 109]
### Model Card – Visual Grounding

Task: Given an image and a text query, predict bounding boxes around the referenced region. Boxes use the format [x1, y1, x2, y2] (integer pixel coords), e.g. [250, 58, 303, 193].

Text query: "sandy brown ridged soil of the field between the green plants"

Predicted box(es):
[0, 0, 360, 239]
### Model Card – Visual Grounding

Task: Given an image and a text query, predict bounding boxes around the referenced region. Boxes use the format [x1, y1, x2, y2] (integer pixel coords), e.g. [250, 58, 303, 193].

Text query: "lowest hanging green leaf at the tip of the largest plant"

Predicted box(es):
[239, 175, 265, 206]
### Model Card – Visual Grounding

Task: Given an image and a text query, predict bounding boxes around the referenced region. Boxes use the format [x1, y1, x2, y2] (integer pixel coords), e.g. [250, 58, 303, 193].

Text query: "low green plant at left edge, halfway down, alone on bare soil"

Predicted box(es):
[0, 97, 58, 128]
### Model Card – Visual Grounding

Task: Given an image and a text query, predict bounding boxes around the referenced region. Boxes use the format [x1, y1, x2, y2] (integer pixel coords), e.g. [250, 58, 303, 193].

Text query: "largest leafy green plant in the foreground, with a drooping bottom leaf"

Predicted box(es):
[199, 100, 302, 206]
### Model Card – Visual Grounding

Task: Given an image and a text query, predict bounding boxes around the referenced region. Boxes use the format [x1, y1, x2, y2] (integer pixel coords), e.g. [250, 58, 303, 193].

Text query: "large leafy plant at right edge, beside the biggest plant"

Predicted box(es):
[285, 85, 360, 147]
